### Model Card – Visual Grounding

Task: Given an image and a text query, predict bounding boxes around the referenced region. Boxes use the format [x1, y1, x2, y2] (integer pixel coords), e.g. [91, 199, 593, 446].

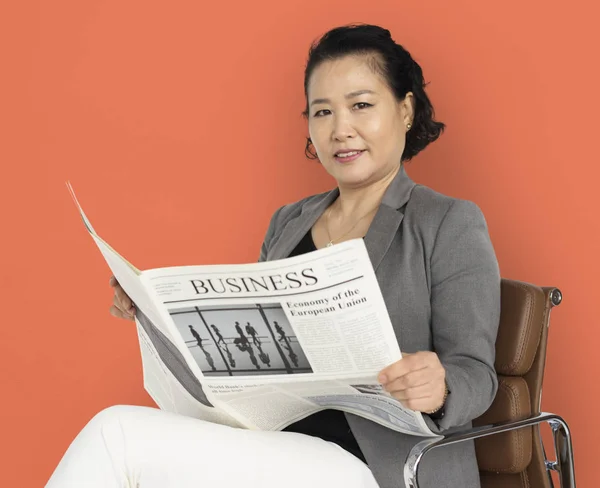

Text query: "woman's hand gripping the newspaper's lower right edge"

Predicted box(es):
[378, 351, 446, 412]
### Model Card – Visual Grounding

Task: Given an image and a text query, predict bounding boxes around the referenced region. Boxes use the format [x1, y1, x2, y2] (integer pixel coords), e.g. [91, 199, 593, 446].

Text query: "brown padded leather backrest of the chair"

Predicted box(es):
[474, 279, 562, 488]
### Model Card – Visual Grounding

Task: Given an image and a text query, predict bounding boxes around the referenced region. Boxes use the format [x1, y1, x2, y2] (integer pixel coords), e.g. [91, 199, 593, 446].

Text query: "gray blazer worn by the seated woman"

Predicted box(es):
[260, 168, 500, 488]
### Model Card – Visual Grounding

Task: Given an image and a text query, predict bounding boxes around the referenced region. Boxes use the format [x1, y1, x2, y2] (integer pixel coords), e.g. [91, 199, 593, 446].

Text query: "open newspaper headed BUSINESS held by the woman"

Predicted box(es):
[68, 185, 436, 436]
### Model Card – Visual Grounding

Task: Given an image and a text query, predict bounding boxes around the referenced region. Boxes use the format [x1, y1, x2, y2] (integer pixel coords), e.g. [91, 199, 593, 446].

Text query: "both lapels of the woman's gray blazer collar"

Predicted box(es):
[269, 165, 415, 270]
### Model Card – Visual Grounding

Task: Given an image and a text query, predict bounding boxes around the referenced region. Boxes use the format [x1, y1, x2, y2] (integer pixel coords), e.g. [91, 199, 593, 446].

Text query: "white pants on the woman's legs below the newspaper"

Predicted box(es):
[46, 406, 377, 488]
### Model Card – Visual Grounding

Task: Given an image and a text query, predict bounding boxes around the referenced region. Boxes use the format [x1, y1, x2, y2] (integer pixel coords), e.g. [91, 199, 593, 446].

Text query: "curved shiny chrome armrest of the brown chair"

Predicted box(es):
[404, 412, 575, 488]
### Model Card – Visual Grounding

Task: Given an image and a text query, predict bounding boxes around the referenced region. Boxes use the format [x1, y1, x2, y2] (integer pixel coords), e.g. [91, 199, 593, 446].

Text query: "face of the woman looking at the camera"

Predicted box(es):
[307, 56, 413, 188]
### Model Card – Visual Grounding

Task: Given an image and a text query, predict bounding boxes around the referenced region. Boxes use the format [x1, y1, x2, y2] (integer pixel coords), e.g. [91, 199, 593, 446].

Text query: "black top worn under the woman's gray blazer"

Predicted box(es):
[284, 231, 367, 463]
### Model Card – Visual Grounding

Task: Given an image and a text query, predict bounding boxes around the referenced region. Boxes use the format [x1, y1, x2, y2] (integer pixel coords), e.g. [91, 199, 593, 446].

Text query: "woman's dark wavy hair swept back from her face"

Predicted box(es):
[302, 24, 445, 162]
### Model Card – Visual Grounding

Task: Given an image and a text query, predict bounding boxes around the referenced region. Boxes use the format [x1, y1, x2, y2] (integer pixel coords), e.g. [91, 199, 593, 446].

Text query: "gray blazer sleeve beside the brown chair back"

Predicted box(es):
[431, 200, 500, 430]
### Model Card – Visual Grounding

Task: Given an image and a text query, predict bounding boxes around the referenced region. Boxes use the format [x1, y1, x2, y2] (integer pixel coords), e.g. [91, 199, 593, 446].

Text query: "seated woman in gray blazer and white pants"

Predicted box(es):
[48, 25, 500, 488]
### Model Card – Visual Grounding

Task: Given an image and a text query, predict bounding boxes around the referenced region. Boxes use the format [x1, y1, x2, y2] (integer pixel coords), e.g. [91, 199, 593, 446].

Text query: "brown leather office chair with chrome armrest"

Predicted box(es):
[404, 279, 575, 488]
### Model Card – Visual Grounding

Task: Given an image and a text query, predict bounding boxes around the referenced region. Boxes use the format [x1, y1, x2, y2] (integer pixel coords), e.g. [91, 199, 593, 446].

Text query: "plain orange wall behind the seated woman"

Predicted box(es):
[0, 0, 600, 488]
